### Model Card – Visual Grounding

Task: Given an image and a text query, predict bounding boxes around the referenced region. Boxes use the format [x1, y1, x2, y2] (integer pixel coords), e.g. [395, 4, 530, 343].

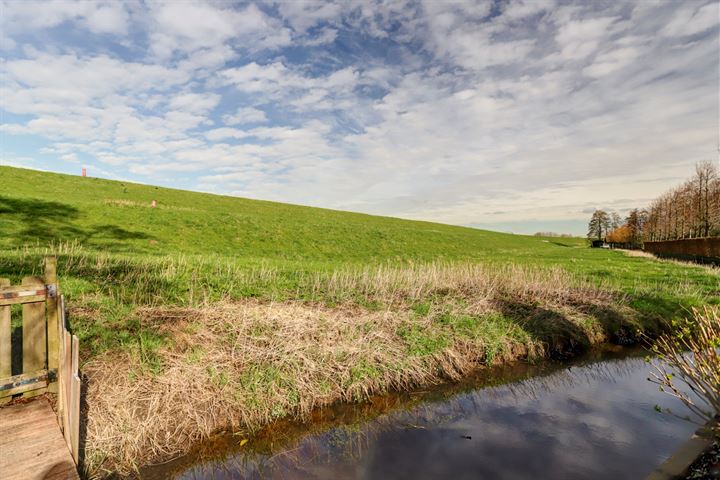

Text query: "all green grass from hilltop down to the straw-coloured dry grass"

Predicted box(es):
[0, 167, 720, 351]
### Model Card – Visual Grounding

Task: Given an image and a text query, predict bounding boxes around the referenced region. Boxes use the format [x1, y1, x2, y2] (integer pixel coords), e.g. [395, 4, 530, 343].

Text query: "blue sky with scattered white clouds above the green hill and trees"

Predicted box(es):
[0, 0, 720, 234]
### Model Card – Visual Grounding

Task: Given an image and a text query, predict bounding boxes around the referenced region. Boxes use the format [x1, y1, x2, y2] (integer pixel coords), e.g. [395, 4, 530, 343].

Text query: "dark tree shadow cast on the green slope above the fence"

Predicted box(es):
[0, 196, 153, 251]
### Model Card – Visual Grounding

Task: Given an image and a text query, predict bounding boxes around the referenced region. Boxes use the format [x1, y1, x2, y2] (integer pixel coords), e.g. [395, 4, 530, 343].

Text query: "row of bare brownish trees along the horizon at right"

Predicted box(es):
[588, 161, 720, 248]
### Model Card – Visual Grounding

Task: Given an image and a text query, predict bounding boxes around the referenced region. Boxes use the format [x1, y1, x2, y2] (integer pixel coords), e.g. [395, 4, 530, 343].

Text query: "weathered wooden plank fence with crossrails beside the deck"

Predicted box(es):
[0, 257, 80, 464]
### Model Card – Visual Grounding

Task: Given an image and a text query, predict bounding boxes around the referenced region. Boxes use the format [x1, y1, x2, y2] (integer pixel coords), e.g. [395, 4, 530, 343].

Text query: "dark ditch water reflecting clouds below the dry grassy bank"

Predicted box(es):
[142, 350, 696, 480]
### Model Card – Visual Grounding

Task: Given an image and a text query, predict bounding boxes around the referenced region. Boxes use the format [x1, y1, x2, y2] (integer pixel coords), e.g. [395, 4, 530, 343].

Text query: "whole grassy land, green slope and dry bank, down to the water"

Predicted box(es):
[0, 167, 720, 475]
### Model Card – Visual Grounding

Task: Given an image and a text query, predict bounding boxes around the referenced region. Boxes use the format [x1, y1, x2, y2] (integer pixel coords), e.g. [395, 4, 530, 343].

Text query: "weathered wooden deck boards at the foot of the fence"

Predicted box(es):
[0, 398, 80, 480]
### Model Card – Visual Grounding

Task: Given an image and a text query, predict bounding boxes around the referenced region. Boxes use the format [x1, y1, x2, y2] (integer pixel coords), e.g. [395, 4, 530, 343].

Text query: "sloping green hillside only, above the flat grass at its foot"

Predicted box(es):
[0, 167, 584, 262]
